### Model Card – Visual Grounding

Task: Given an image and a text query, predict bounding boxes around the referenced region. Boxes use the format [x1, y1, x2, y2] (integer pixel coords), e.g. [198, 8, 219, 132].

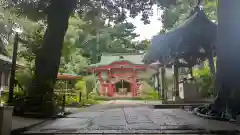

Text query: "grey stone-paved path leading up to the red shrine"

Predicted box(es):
[25, 107, 239, 134]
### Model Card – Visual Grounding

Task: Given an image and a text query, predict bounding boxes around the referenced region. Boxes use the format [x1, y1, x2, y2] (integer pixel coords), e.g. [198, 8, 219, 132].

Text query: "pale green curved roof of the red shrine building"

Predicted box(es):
[90, 53, 144, 67]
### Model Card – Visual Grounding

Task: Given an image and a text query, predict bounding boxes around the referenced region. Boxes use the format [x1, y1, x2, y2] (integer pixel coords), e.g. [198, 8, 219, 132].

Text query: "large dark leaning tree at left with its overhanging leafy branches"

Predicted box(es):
[5, 0, 156, 115]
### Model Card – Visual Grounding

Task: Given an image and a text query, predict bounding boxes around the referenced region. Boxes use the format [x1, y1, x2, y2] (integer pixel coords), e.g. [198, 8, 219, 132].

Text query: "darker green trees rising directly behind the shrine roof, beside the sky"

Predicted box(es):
[76, 20, 141, 63]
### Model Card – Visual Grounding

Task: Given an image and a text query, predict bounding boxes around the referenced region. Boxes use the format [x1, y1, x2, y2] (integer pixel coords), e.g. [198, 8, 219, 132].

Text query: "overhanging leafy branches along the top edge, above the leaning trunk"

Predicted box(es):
[6, 0, 155, 24]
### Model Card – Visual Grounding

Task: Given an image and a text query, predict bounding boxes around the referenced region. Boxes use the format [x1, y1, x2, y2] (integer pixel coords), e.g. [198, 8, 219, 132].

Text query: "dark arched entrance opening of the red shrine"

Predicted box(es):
[115, 80, 131, 96]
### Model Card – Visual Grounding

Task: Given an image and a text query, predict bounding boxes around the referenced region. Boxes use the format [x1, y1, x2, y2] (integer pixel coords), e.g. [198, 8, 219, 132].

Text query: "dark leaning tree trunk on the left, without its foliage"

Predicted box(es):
[29, 0, 76, 116]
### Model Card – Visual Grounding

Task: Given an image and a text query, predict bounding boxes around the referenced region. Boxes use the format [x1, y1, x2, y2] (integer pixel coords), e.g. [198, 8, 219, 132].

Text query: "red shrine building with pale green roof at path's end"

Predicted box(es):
[90, 53, 148, 97]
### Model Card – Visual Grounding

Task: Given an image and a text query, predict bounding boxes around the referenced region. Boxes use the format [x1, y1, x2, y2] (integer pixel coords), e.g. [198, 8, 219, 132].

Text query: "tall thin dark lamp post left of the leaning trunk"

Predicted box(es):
[8, 28, 22, 104]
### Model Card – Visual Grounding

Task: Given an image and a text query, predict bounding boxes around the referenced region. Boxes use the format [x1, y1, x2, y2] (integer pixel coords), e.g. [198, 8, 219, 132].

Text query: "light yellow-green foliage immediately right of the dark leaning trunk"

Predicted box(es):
[59, 16, 90, 74]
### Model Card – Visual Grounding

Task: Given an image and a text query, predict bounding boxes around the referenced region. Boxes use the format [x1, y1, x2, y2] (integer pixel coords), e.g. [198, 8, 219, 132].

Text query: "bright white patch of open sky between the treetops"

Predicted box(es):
[127, 5, 162, 40]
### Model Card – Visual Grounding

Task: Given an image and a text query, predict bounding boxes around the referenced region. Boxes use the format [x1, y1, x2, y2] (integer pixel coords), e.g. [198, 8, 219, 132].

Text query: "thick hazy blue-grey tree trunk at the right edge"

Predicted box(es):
[196, 0, 240, 118]
